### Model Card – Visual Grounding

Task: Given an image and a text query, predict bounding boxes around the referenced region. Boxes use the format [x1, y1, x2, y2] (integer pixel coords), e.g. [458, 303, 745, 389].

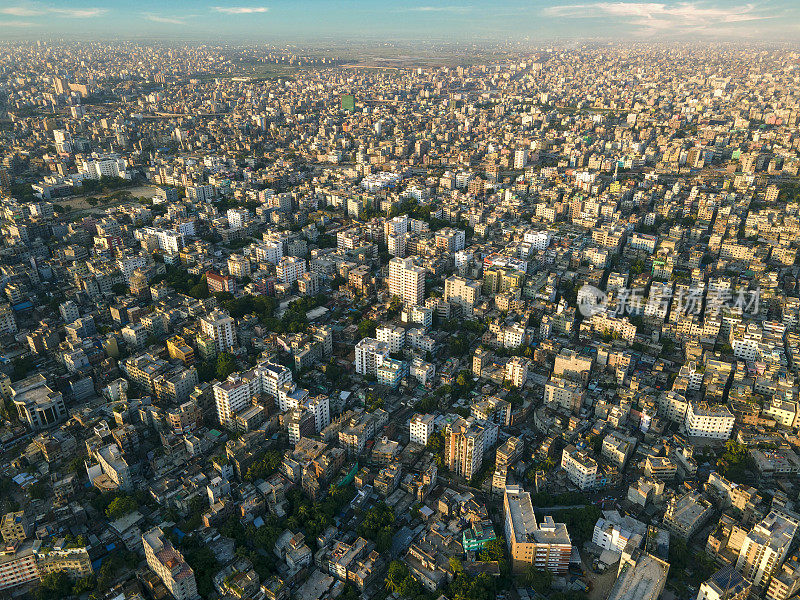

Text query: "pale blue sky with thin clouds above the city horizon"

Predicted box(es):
[0, 0, 800, 43]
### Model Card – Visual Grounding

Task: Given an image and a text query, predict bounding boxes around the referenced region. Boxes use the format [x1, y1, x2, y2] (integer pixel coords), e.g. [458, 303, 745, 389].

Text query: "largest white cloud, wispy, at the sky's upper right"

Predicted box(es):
[543, 2, 776, 35]
